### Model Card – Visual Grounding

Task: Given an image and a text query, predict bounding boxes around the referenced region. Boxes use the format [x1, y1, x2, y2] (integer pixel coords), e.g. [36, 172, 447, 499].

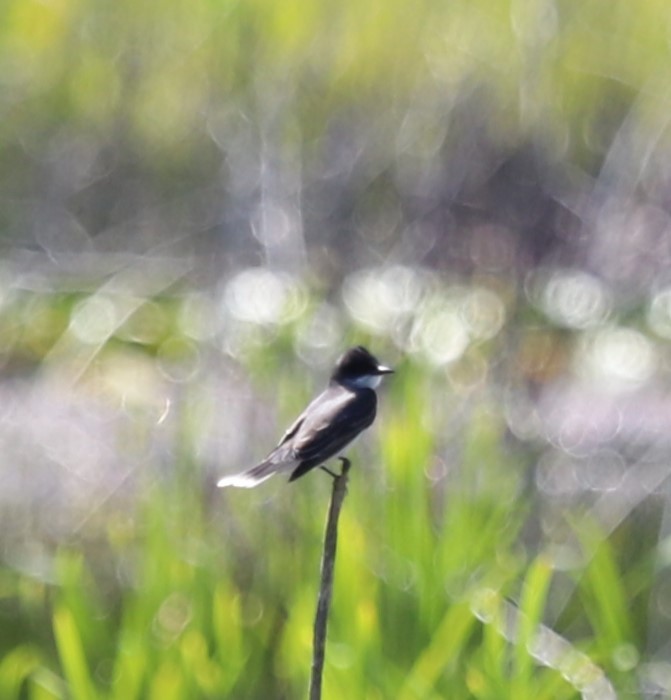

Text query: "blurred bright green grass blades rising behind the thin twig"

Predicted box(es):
[0, 322, 653, 700]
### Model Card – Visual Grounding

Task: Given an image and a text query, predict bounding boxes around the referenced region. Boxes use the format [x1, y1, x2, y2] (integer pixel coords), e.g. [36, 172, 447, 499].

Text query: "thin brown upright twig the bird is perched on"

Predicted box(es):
[310, 457, 350, 700]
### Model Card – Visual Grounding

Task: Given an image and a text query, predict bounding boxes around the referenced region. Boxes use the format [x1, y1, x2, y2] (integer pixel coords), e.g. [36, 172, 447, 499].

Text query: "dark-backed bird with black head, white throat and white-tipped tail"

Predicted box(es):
[217, 345, 394, 488]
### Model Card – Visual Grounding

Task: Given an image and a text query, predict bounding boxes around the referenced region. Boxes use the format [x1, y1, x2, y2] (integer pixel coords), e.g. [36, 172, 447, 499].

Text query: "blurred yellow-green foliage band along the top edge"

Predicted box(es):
[7, 0, 669, 150]
